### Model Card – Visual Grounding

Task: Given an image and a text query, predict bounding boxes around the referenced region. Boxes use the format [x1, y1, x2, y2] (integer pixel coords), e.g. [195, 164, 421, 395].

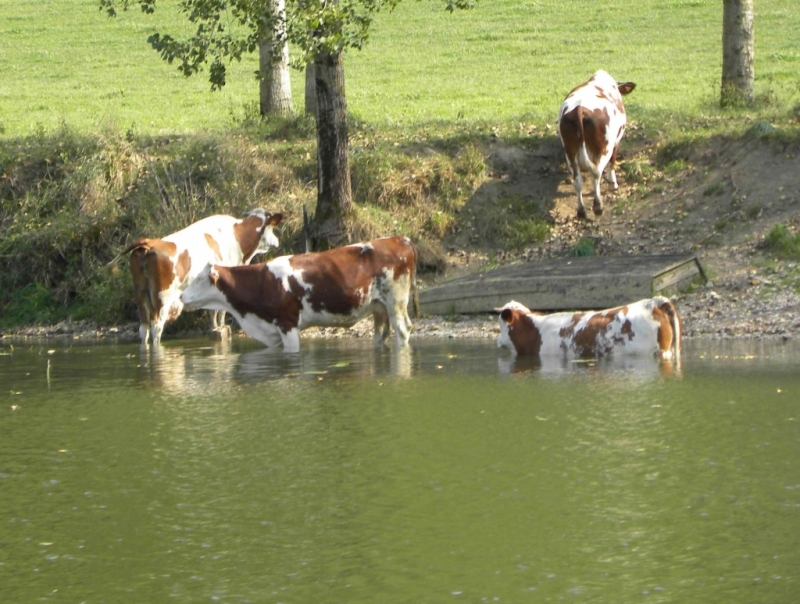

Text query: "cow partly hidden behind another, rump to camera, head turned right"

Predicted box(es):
[122, 208, 283, 345]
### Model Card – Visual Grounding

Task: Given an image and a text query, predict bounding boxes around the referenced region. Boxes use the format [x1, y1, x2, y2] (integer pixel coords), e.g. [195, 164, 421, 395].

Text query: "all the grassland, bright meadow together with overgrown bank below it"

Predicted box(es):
[0, 0, 800, 329]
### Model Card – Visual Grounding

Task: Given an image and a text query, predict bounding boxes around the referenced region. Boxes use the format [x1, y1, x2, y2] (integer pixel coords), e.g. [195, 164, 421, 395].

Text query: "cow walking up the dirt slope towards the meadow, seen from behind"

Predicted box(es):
[558, 70, 636, 219]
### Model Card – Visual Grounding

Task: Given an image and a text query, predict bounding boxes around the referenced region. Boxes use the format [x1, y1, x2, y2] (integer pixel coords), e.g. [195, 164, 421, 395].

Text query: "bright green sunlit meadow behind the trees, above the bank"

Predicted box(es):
[0, 0, 800, 136]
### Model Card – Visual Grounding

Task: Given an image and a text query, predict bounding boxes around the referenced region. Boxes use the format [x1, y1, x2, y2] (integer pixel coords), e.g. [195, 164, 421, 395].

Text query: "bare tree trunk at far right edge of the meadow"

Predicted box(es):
[720, 0, 756, 107]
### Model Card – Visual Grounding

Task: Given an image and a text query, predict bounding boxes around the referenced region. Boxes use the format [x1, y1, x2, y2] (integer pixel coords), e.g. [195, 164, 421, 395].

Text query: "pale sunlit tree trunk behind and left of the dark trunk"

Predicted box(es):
[258, 0, 294, 115]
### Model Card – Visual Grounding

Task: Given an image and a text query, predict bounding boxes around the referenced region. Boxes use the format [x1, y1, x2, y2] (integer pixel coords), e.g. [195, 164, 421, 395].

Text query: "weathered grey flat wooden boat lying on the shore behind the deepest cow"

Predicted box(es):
[420, 256, 702, 315]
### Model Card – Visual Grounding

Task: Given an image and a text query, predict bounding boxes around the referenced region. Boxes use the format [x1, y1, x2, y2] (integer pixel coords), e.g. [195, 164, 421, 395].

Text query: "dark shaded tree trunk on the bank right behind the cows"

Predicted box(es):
[311, 52, 353, 250]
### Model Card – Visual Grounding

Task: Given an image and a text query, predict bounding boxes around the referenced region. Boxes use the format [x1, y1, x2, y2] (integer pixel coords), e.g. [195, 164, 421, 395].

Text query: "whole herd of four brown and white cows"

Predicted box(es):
[122, 71, 681, 359]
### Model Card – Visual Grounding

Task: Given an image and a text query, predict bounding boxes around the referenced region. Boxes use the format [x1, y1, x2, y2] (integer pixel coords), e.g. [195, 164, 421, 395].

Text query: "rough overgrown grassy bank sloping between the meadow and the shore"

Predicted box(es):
[0, 114, 800, 329]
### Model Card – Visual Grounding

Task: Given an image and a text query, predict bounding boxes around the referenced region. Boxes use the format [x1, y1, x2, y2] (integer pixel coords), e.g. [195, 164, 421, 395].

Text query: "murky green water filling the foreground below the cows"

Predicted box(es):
[0, 339, 800, 604]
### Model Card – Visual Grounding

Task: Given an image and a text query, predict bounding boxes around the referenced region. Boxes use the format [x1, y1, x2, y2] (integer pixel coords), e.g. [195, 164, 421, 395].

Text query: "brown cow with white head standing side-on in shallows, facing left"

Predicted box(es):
[181, 235, 417, 352]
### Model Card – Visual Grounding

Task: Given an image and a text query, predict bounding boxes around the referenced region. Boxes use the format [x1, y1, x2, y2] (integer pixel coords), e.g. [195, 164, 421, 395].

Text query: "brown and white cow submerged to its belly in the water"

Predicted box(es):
[497, 296, 681, 359]
